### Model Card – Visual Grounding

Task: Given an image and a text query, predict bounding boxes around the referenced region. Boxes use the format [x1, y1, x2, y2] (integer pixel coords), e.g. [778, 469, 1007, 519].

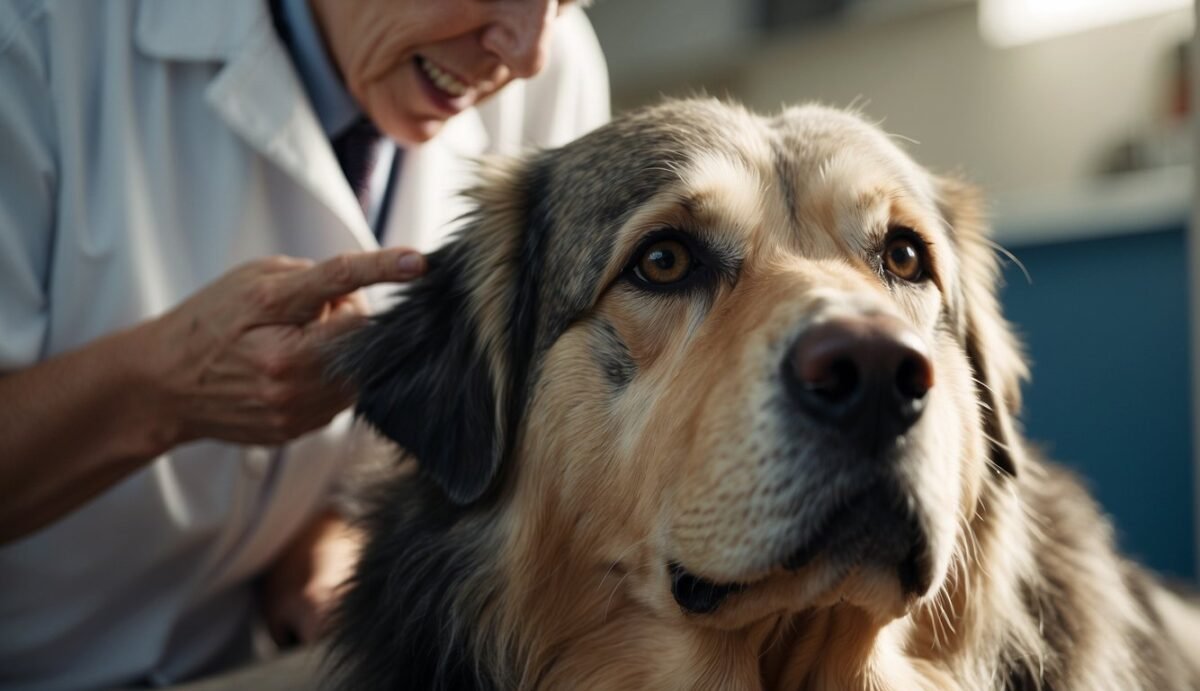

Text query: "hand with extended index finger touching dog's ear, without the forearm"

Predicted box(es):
[146, 250, 425, 444]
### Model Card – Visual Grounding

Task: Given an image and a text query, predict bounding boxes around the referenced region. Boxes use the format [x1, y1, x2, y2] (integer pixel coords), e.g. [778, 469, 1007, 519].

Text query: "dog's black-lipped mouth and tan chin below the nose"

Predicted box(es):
[667, 487, 934, 627]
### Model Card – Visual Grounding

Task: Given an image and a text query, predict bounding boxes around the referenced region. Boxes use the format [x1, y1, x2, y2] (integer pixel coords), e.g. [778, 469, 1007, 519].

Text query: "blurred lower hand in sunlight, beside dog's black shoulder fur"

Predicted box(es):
[262, 512, 364, 648]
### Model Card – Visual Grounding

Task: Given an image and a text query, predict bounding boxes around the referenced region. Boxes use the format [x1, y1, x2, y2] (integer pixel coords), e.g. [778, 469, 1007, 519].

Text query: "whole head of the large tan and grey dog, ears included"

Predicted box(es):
[343, 101, 1025, 629]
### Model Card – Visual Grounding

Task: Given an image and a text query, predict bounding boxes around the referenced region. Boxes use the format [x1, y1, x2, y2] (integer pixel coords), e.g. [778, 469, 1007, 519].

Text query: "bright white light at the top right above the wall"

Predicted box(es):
[979, 0, 1192, 47]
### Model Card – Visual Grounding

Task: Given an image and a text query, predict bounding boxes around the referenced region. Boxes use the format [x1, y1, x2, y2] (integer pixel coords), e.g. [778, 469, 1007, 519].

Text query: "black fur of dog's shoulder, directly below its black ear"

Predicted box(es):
[330, 475, 496, 691]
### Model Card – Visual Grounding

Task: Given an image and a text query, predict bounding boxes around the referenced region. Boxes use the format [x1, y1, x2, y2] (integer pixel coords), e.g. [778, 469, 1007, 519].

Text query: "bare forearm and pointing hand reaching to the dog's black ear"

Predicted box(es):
[0, 250, 425, 543]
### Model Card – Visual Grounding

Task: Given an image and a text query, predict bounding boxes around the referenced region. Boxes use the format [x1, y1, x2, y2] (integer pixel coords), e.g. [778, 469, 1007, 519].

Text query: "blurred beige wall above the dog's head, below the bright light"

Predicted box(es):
[592, 0, 1192, 196]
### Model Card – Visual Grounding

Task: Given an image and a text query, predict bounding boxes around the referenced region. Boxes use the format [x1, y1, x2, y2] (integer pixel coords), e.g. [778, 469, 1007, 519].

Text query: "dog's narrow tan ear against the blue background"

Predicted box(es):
[938, 178, 1030, 476]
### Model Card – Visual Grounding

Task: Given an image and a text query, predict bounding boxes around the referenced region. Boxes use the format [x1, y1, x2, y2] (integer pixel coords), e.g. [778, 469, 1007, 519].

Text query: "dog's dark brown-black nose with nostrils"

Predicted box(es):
[784, 314, 934, 449]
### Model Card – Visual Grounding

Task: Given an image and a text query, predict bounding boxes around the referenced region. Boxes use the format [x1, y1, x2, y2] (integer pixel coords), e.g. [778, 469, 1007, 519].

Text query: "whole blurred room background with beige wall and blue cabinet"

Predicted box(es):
[588, 0, 1200, 581]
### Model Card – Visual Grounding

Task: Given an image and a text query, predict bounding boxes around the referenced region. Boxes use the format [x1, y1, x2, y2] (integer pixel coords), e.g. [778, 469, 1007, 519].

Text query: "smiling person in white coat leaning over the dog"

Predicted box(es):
[0, 0, 608, 689]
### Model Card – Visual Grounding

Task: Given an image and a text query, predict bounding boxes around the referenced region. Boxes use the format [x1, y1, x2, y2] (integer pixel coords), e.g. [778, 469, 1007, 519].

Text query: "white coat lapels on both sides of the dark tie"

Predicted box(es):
[136, 0, 503, 254]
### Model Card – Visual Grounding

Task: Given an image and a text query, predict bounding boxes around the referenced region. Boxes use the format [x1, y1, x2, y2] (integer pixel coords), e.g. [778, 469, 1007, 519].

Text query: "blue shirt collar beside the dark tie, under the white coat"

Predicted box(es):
[276, 0, 362, 139]
